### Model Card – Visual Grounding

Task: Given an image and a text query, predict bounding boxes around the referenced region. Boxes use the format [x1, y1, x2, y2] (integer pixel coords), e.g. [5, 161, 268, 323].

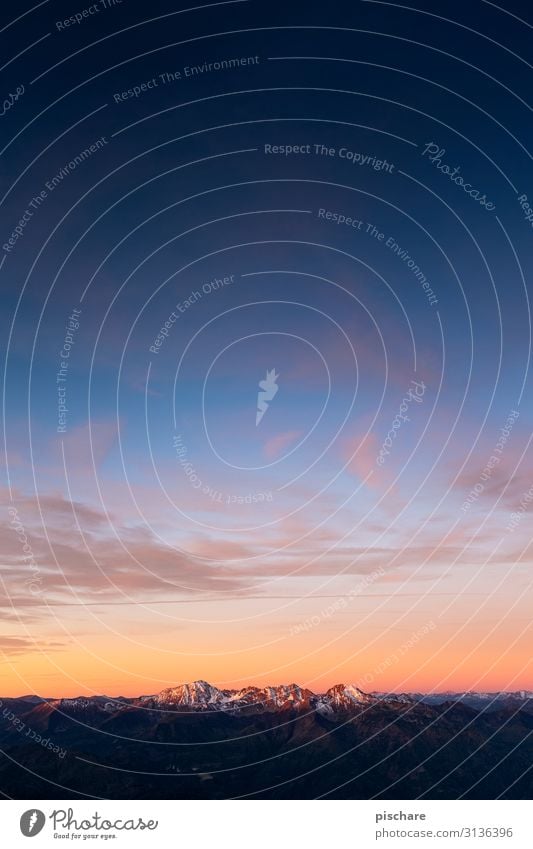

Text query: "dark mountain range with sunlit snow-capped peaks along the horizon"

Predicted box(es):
[0, 681, 533, 799]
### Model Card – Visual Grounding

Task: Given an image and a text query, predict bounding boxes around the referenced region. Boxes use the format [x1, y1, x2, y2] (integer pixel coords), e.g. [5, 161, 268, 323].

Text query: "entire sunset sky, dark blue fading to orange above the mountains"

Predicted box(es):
[0, 0, 533, 697]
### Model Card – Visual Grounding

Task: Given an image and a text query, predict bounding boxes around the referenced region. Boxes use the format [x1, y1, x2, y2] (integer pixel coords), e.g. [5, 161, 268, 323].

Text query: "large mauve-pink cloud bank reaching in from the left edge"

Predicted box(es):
[0, 486, 258, 619]
